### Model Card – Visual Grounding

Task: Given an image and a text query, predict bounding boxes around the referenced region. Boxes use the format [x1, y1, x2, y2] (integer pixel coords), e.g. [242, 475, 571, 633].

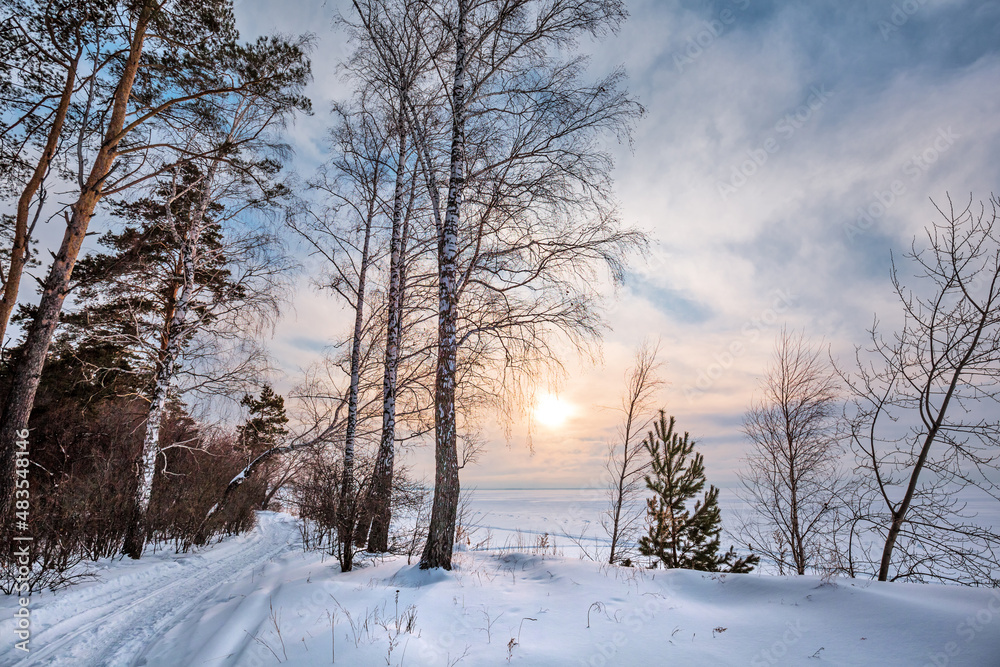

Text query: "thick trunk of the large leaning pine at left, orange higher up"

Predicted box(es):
[0, 7, 155, 516]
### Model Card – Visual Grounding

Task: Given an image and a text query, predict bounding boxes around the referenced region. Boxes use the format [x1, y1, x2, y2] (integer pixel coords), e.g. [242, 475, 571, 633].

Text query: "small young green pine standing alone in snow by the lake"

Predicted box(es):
[639, 410, 759, 573]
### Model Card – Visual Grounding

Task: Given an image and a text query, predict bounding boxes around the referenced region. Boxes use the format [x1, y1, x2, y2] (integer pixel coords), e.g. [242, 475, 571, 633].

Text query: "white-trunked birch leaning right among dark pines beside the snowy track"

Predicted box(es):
[125, 170, 288, 558]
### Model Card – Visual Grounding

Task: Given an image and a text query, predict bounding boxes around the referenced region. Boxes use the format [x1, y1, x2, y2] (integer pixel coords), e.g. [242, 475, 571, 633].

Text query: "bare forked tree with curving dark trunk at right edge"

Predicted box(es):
[841, 197, 1000, 586]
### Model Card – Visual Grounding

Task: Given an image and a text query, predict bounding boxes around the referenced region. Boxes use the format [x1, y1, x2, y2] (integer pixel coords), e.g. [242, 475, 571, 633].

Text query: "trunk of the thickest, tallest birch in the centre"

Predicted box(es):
[420, 0, 468, 570]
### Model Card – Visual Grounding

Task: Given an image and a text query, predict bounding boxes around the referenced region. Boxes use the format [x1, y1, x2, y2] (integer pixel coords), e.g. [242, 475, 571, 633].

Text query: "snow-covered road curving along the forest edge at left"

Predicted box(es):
[0, 513, 299, 667]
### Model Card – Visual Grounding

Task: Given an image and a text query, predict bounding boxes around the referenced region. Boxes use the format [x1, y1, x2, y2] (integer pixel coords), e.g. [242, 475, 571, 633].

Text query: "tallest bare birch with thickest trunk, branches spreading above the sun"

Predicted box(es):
[411, 0, 641, 569]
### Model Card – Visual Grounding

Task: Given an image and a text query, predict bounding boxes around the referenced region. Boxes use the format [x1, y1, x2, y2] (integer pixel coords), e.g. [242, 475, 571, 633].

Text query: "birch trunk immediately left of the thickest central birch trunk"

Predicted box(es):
[358, 125, 406, 553]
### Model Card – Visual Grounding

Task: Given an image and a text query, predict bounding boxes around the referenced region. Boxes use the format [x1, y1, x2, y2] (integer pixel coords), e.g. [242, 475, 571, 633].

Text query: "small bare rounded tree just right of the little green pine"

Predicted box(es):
[735, 329, 843, 574]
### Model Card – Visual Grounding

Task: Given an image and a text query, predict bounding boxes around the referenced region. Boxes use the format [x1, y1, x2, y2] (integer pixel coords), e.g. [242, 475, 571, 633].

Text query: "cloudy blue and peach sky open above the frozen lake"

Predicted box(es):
[230, 0, 1000, 488]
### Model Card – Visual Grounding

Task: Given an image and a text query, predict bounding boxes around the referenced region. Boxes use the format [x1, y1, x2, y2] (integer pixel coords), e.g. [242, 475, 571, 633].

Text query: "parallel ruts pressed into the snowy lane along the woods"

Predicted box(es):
[0, 520, 294, 667]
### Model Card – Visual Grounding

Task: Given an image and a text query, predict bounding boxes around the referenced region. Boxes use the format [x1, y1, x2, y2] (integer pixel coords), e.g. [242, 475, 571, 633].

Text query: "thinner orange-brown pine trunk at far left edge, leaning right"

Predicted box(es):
[0, 54, 80, 343]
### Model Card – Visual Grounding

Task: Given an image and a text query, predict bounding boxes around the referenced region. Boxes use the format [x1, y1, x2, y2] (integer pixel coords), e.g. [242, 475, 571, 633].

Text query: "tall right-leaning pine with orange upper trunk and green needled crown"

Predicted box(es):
[0, 0, 309, 511]
